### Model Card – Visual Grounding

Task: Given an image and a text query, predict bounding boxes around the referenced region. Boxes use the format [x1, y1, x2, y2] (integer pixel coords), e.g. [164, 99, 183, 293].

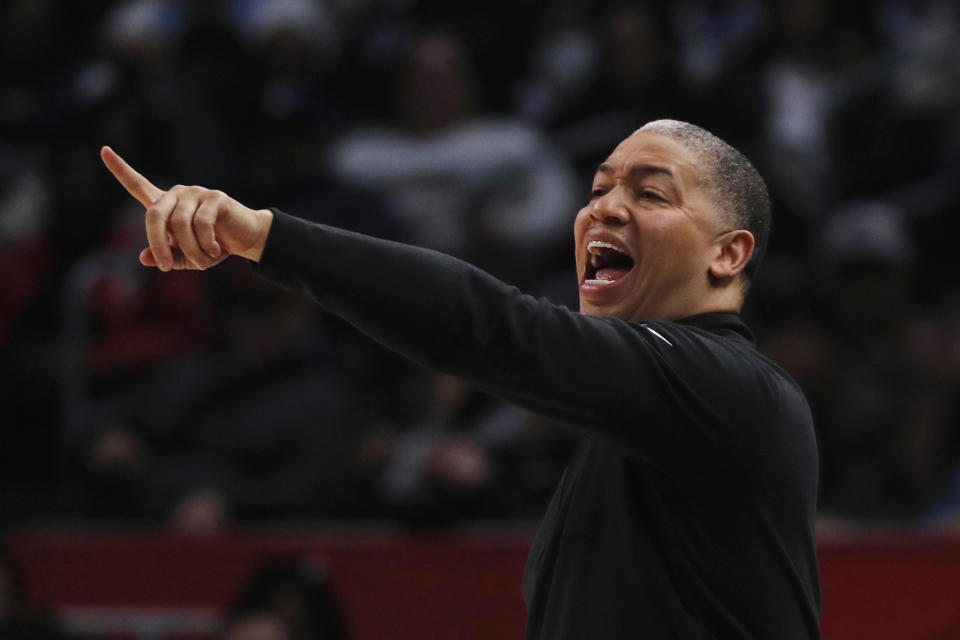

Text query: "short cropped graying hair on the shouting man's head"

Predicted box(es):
[638, 120, 770, 280]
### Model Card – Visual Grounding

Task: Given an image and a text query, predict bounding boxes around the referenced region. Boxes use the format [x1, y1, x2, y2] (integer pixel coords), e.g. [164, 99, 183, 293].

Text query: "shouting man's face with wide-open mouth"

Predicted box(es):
[574, 132, 727, 320]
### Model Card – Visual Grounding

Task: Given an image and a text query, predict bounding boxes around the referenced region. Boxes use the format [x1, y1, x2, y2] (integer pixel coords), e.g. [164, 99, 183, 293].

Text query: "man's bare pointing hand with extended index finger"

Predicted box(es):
[100, 147, 273, 271]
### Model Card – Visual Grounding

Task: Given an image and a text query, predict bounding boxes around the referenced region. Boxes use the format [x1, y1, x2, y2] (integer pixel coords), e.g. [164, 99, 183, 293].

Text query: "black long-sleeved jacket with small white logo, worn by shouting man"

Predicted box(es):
[259, 211, 820, 640]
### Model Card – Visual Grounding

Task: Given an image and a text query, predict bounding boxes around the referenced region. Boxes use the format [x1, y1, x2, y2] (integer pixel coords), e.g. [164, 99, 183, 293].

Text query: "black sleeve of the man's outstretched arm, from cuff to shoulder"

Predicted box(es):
[257, 211, 776, 475]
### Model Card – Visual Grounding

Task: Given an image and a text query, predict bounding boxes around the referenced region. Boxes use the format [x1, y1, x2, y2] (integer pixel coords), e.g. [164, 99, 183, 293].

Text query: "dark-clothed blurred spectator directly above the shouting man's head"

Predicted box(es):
[517, 2, 697, 180]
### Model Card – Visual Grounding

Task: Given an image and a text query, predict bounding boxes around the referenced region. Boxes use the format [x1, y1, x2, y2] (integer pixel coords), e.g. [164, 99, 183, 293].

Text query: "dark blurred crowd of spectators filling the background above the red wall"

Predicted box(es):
[0, 0, 960, 531]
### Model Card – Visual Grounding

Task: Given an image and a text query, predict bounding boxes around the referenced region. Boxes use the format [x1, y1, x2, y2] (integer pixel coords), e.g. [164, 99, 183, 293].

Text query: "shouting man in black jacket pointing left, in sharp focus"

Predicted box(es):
[102, 120, 820, 640]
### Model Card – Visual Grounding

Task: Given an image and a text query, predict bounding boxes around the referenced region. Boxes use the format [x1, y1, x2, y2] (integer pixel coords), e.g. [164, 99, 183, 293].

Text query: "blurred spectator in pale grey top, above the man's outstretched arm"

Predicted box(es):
[331, 32, 575, 278]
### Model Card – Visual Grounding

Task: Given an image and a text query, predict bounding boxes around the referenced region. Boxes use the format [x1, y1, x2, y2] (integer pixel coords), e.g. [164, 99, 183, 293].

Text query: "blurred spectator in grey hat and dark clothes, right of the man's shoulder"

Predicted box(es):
[818, 203, 958, 518]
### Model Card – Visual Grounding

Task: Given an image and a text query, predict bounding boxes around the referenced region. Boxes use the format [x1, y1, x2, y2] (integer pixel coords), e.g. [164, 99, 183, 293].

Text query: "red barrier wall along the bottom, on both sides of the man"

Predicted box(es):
[9, 530, 960, 640]
